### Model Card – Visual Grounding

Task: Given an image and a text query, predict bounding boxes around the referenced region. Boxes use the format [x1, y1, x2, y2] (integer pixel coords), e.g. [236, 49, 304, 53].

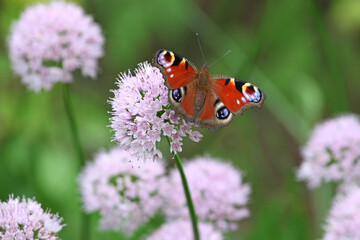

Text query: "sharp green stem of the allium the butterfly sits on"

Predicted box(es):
[166, 136, 200, 240]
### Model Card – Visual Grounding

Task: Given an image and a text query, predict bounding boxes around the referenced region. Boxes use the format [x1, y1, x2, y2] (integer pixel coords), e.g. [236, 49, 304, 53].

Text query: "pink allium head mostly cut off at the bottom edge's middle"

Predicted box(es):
[147, 220, 223, 240]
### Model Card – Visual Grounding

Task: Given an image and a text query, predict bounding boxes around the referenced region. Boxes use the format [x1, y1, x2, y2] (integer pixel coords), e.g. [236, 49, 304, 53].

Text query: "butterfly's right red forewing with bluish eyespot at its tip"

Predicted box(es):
[211, 75, 265, 114]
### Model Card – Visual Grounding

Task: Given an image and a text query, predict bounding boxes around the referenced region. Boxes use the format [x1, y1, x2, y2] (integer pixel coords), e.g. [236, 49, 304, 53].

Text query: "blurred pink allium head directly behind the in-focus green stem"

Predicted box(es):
[162, 157, 250, 231]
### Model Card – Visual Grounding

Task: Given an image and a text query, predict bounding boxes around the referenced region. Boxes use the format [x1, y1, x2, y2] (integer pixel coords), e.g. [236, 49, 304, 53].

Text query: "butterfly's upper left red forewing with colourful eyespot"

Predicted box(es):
[153, 49, 199, 89]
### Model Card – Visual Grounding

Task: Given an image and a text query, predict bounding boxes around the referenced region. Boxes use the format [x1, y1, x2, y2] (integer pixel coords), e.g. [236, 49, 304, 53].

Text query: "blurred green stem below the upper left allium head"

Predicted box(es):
[63, 84, 90, 240]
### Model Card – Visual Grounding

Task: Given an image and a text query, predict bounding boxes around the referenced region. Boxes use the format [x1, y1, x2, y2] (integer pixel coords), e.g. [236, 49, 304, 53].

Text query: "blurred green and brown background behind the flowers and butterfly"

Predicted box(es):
[0, 0, 360, 240]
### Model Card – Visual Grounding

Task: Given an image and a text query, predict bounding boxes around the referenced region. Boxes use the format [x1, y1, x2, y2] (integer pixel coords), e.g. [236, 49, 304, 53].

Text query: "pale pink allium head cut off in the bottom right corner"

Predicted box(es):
[323, 187, 360, 240]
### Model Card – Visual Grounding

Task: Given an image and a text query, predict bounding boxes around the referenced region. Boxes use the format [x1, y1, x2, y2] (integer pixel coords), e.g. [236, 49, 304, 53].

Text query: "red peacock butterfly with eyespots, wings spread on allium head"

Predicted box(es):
[153, 49, 265, 131]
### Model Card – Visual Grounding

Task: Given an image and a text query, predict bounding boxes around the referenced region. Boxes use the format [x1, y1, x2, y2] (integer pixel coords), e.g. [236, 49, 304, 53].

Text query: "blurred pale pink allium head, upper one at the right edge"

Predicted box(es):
[298, 114, 360, 188]
